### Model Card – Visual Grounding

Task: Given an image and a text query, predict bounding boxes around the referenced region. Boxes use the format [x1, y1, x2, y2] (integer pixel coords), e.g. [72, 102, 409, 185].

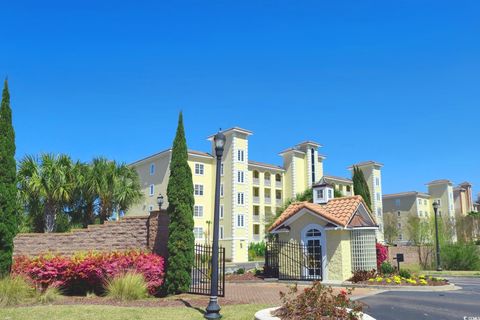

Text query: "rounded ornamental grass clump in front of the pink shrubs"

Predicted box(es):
[105, 272, 148, 301]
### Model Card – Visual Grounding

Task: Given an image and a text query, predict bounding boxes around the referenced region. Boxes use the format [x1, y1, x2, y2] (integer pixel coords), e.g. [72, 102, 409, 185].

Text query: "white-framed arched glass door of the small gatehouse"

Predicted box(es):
[302, 224, 327, 280]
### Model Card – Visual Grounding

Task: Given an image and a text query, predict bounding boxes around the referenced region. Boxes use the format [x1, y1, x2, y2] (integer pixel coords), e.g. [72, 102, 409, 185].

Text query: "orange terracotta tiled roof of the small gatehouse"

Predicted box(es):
[268, 195, 377, 232]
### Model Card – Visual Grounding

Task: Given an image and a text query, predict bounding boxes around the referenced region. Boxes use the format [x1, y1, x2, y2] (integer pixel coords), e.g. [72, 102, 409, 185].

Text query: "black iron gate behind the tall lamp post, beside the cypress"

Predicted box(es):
[188, 244, 225, 297]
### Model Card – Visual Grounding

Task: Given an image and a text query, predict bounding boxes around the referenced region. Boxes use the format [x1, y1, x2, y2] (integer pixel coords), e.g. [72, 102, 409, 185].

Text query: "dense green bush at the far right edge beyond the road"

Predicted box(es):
[440, 243, 480, 271]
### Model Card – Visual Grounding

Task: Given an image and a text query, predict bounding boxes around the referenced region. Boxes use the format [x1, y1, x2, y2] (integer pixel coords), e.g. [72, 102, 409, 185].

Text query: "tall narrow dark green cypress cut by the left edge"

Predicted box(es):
[0, 80, 18, 274]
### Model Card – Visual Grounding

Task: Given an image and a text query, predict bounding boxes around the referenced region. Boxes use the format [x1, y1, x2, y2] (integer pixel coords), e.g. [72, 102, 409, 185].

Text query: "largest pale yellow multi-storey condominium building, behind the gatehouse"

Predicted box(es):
[127, 127, 383, 262]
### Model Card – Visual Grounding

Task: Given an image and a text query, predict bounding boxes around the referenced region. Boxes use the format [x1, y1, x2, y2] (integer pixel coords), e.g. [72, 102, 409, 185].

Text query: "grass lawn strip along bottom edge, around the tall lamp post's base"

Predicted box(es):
[0, 304, 269, 320]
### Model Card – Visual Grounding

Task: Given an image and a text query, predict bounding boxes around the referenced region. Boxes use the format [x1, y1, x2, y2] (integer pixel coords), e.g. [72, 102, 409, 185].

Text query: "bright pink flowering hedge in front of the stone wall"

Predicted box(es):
[12, 251, 164, 295]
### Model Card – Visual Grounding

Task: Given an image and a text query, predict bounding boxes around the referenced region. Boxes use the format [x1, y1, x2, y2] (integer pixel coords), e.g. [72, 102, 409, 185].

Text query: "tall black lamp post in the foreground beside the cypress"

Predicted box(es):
[205, 132, 226, 319]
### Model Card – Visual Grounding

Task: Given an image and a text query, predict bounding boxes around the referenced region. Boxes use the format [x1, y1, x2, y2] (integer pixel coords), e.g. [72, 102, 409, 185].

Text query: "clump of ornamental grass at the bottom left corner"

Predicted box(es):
[0, 277, 35, 306]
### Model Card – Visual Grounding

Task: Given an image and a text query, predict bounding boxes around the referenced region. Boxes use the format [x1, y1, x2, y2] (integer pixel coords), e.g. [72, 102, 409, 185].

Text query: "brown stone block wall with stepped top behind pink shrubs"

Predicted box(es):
[13, 211, 168, 257]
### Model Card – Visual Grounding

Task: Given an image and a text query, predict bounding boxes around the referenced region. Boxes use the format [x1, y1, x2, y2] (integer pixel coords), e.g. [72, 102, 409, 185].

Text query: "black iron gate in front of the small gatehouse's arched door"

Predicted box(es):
[264, 239, 323, 281]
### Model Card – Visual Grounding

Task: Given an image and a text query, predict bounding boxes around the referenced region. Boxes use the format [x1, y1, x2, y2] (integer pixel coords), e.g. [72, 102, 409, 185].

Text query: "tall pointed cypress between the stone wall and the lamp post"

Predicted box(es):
[165, 112, 195, 294]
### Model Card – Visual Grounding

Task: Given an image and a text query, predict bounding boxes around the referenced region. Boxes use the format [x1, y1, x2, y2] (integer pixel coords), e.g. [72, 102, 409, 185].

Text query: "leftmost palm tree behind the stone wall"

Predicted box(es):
[18, 153, 74, 232]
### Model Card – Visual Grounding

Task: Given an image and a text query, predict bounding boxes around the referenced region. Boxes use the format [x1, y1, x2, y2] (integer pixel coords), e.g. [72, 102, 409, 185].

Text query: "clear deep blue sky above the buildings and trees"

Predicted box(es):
[0, 0, 480, 193]
